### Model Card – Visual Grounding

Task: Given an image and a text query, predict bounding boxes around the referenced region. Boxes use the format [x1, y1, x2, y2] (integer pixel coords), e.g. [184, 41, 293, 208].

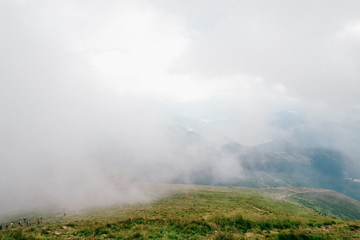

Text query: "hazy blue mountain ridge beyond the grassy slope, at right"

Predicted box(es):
[215, 142, 360, 200]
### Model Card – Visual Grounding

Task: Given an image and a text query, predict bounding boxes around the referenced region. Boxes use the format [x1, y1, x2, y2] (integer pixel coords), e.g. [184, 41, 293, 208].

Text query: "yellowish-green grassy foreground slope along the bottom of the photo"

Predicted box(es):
[0, 185, 360, 239]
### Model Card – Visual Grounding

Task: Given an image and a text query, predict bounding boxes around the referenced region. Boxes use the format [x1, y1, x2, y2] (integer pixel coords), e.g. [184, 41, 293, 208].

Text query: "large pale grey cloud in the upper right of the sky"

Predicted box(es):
[169, 1, 359, 104]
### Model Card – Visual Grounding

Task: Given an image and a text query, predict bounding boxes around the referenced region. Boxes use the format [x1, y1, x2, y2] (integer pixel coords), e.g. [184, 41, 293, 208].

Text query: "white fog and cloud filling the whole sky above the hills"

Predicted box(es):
[0, 0, 360, 217]
